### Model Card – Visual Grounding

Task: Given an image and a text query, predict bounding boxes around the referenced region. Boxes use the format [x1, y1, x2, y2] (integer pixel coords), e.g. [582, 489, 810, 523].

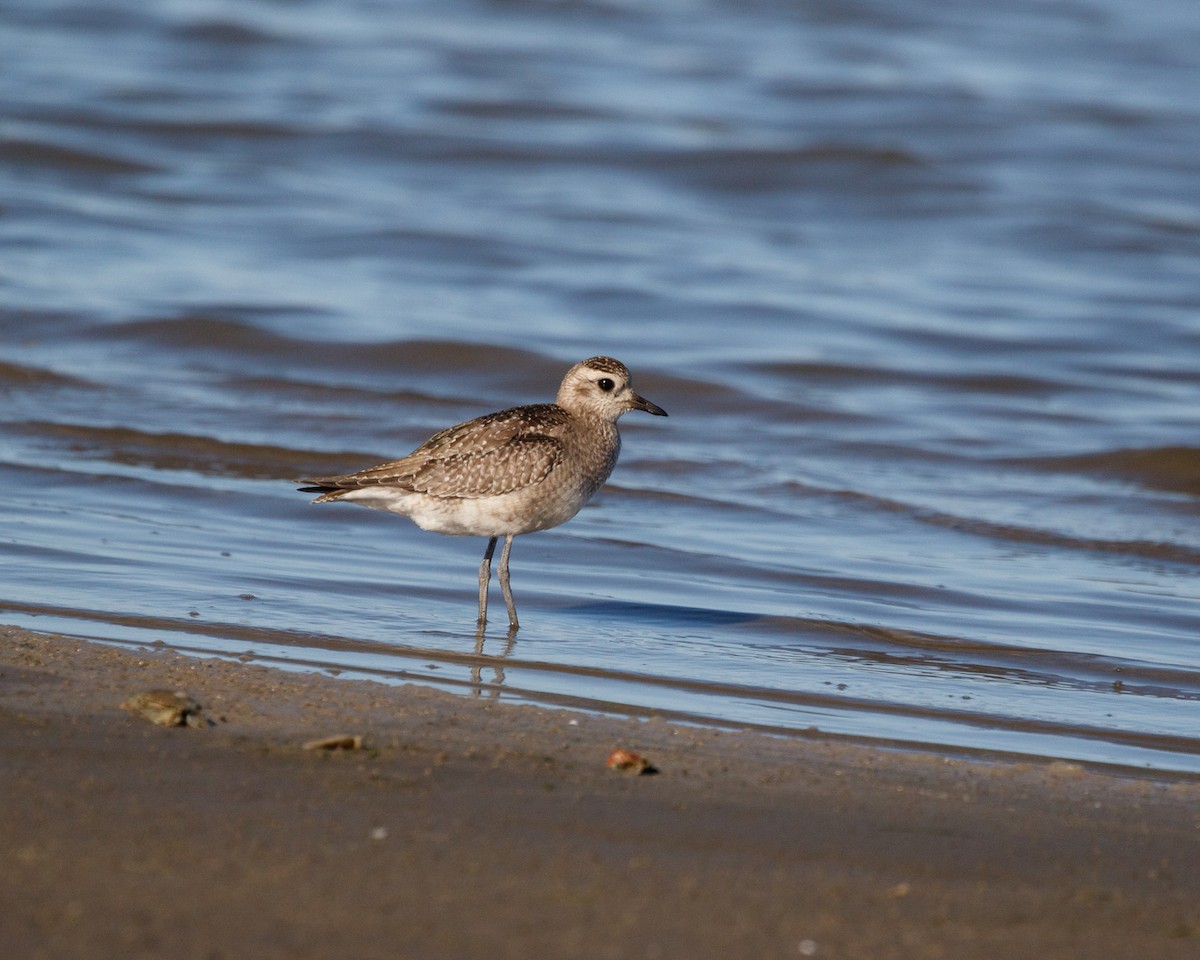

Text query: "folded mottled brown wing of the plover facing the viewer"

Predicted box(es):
[300, 404, 563, 499]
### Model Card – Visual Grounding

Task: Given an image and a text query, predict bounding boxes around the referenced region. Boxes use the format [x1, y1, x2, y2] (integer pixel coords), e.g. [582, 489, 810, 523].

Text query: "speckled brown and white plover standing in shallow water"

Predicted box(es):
[291, 356, 667, 630]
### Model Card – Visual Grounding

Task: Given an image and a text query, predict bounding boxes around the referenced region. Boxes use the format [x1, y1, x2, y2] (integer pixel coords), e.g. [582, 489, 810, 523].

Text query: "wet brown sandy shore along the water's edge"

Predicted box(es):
[0, 628, 1200, 960]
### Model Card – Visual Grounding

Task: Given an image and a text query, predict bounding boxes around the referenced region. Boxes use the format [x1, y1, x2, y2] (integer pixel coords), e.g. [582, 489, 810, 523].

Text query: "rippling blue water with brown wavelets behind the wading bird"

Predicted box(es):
[0, 0, 1200, 773]
